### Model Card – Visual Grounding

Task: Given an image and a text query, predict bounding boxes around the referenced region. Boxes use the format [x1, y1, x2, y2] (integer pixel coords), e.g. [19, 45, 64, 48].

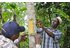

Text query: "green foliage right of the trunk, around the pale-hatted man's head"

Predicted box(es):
[35, 2, 70, 47]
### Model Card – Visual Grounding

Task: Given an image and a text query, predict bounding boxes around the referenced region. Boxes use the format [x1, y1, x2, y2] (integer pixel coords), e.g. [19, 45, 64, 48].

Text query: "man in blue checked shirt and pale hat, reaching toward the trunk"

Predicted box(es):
[37, 17, 62, 48]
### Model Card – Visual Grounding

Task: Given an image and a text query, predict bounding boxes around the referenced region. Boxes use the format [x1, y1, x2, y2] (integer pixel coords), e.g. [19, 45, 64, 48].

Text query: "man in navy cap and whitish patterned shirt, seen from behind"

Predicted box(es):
[0, 21, 26, 48]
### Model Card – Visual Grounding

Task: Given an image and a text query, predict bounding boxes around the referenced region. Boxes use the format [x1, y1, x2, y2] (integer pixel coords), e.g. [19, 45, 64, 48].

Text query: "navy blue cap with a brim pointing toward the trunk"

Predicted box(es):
[2, 21, 25, 37]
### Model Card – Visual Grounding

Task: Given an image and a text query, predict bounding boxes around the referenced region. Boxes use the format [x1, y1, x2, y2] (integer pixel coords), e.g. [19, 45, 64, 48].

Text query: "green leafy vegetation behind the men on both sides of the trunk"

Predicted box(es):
[0, 2, 70, 48]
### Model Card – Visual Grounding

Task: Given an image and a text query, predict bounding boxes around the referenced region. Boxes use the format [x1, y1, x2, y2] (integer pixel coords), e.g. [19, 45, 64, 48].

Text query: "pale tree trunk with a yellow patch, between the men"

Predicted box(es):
[27, 2, 36, 48]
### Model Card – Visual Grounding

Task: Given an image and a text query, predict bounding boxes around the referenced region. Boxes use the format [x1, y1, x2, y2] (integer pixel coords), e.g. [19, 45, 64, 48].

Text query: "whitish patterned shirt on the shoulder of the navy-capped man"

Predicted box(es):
[0, 37, 17, 48]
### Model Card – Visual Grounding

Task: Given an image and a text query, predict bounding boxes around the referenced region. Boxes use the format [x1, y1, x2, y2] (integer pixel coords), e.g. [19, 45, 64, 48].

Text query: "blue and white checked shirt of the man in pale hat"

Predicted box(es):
[38, 28, 61, 48]
